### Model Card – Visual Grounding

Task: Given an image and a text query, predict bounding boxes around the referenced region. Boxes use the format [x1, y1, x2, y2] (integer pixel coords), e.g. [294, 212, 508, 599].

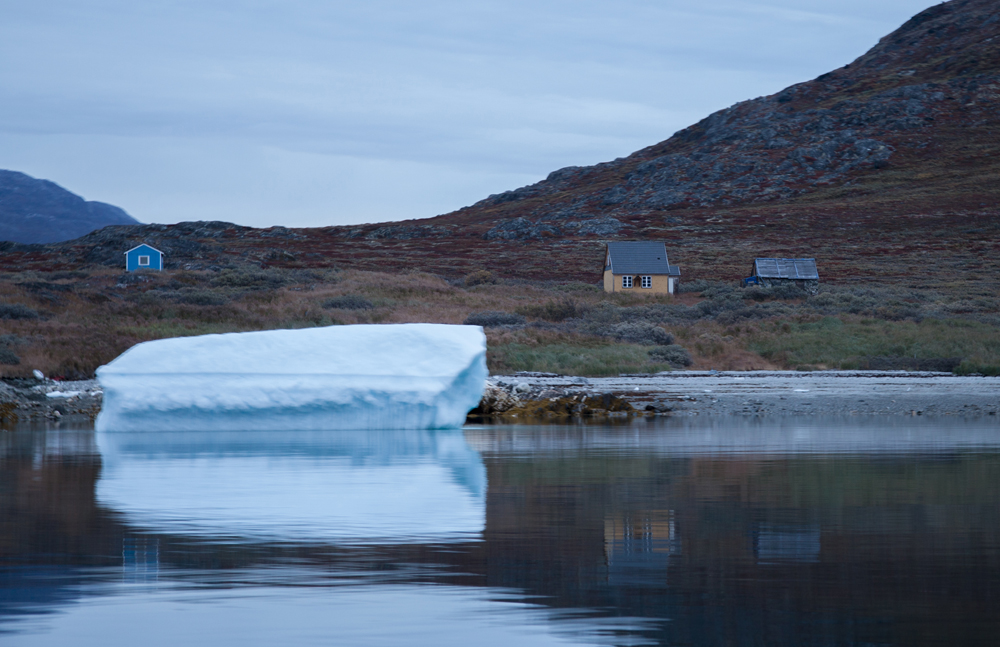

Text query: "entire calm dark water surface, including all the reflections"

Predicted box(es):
[0, 418, 1000, 646]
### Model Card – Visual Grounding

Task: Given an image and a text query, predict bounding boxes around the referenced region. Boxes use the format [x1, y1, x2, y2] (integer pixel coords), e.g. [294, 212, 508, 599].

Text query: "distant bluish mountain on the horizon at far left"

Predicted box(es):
[0, 170, 139, 243]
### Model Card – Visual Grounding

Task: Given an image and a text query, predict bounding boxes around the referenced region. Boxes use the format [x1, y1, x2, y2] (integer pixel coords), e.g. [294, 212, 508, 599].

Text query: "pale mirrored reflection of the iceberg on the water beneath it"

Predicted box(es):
[97, 430, 486, 543]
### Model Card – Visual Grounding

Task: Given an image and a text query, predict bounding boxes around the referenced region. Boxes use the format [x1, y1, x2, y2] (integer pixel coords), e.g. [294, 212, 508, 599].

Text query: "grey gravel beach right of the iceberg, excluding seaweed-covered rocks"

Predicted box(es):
[490, 371, 1000, 420]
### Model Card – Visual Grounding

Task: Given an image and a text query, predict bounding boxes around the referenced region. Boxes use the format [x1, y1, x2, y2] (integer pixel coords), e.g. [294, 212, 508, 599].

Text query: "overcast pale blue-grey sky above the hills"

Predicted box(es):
[0, 0, 933, 226]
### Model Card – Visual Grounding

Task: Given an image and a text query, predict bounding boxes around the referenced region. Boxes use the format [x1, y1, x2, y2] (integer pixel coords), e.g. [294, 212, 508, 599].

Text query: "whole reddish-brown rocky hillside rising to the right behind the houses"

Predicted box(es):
[0, 0, 1000, 294]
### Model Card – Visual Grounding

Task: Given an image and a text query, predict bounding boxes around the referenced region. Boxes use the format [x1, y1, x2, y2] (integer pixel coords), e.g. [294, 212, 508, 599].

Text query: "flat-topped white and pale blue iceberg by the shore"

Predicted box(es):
[97, 324, 487, 431]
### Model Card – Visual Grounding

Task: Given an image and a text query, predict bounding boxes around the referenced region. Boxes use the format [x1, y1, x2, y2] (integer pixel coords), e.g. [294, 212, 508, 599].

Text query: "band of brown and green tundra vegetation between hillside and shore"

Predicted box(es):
[0, 266, 1000, 378]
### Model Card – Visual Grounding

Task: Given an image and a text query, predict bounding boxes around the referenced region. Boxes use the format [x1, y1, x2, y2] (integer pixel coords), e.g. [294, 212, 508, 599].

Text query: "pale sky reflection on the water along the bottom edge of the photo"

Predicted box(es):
[11, 584, 664, 647]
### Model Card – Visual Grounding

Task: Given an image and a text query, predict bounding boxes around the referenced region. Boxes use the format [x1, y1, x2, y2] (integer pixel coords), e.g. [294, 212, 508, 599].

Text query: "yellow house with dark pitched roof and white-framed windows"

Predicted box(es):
[604, 241, 681, 294]
